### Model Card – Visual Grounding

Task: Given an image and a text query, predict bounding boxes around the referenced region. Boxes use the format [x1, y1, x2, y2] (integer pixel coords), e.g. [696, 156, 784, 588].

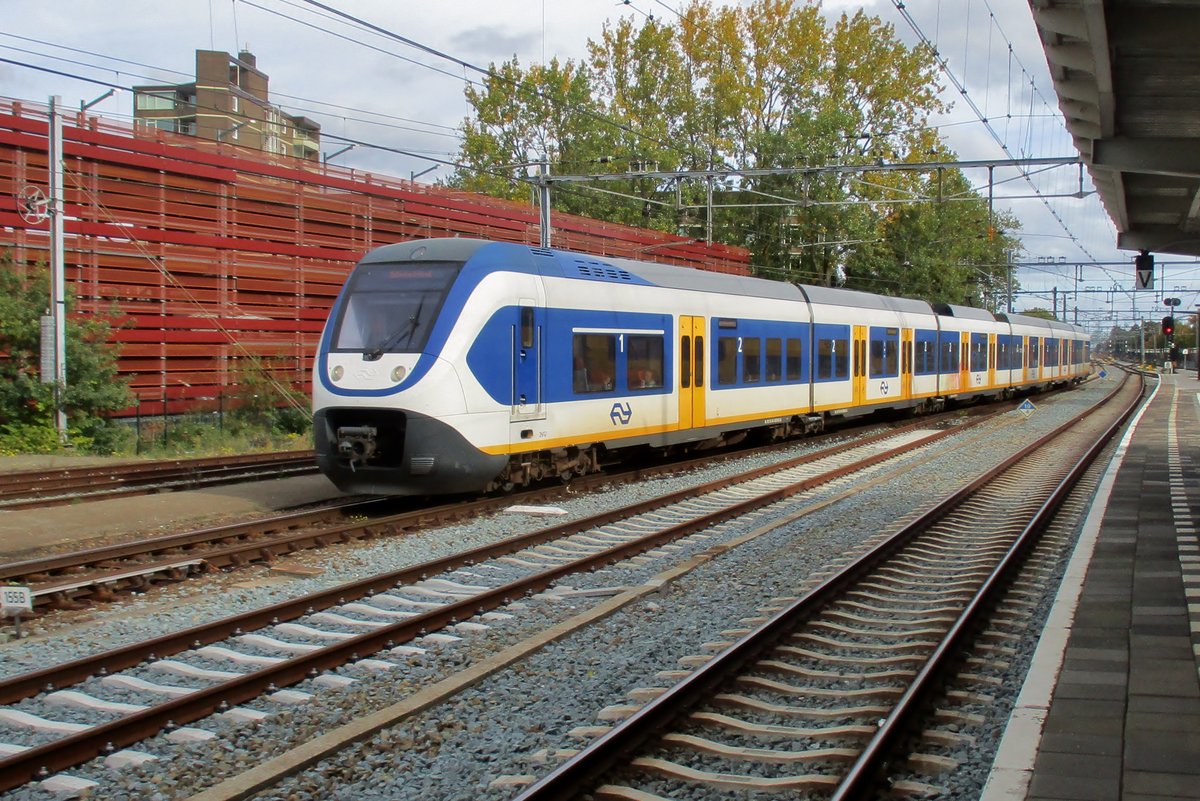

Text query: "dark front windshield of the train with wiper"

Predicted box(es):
[334, 261, 462, 359]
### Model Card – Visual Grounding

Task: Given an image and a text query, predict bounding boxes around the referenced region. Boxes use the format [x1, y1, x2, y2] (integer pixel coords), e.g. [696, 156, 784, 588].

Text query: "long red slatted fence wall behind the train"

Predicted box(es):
[0, 98, 749, 414]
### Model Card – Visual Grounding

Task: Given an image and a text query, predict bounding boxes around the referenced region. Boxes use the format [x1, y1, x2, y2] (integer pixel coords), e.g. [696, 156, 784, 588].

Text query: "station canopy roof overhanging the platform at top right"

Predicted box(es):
[1030, 0, 1200, 255]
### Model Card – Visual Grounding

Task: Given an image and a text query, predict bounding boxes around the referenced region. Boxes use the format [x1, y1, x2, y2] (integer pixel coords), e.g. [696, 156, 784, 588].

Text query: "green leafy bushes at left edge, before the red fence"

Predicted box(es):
[0, 253, 134, 452]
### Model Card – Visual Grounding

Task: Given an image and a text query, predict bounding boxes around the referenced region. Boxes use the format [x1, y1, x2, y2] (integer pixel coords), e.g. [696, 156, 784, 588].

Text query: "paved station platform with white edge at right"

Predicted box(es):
[982, 371, 1200, 801]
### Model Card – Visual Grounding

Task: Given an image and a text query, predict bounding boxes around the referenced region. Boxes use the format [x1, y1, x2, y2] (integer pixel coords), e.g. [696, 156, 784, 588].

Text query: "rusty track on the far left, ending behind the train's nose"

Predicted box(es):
[0, 451, 317, 510]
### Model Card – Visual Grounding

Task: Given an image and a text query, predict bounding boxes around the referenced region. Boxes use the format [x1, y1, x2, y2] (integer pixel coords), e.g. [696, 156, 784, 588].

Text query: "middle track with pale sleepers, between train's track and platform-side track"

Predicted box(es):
[0, 426, 993, 790]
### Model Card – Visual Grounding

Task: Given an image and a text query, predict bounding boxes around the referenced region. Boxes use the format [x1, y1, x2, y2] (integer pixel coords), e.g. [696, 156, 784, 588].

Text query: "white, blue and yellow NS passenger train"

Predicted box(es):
[312, 239, 1091, 495]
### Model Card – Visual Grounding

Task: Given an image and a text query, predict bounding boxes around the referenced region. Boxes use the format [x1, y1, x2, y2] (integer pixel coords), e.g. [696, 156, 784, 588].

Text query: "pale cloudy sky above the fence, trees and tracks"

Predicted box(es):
[0, 0, 1200, 331]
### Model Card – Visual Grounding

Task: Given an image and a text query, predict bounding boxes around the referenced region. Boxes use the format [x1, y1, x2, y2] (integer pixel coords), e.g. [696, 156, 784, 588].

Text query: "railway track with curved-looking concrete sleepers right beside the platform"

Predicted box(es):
[508, 371, 1141, 801]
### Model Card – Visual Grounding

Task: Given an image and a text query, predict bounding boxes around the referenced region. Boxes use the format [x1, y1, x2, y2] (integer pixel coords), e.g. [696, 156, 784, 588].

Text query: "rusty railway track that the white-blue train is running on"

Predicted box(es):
[0, 404, 988, 610]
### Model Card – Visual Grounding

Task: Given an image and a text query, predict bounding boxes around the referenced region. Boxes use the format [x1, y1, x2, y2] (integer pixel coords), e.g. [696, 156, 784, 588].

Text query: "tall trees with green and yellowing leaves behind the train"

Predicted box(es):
[454, 0, 1018, 305]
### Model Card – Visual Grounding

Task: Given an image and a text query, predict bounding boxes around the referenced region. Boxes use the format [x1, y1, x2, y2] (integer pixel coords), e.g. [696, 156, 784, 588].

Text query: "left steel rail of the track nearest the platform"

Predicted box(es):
[512, 371, 1140, 801]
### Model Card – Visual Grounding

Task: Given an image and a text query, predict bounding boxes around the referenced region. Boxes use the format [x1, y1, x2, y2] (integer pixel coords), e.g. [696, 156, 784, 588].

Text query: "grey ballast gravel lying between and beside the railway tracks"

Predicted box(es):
[0, 381, 1112, 801]
